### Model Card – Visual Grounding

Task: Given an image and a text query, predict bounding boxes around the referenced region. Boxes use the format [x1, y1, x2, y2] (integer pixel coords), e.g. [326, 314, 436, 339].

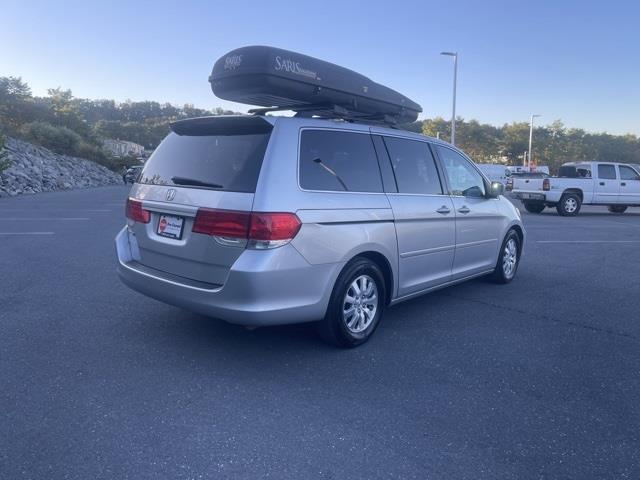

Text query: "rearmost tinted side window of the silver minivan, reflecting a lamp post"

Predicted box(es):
[299, 130, 382, 192]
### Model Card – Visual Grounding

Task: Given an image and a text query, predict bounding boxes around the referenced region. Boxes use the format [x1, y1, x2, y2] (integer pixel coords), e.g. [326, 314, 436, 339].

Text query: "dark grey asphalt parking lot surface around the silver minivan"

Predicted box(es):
[0, 187, 640, 479]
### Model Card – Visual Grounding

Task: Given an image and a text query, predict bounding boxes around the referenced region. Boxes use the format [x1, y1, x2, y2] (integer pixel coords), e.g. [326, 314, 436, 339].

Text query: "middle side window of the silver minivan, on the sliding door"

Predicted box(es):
[384, 137, 442, 195]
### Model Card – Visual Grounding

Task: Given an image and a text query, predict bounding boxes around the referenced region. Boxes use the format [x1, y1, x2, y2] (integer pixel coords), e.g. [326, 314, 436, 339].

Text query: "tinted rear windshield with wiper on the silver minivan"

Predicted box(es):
[138, 132, 270, 193]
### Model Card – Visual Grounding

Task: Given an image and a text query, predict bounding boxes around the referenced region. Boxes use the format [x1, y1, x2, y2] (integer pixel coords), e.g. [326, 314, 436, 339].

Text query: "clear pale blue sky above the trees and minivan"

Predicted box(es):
[0, 0, 640, 135]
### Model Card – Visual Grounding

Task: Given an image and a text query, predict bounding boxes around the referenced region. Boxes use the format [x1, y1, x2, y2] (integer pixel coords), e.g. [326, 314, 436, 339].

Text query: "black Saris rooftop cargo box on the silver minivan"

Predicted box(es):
[209, 46, 422, 123]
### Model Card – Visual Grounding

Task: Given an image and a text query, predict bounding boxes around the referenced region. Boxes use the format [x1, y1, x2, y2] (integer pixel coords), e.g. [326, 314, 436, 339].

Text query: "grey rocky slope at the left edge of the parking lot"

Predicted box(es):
[0, 138, 122, 197]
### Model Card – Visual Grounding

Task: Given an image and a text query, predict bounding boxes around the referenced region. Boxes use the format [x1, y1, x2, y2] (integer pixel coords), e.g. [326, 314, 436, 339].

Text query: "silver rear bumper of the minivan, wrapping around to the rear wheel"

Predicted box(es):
[115, 227, 344, 326]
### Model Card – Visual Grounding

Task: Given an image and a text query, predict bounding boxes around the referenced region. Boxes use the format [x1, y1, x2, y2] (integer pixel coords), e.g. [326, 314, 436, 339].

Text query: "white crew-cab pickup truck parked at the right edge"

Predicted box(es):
[512, 162, 640, 216]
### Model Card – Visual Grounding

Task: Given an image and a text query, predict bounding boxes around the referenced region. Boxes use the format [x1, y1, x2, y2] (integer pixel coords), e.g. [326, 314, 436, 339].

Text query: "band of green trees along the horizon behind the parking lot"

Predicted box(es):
[5, 77, 640, 170]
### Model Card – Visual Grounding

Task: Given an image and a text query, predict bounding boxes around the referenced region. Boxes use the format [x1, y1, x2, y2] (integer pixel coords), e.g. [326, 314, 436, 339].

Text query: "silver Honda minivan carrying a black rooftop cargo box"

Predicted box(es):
[116, 115, 525, 347]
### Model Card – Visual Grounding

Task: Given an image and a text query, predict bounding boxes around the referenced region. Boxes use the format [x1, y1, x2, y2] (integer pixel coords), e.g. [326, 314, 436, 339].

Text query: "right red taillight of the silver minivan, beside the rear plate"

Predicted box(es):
[193, 208, 302, 250]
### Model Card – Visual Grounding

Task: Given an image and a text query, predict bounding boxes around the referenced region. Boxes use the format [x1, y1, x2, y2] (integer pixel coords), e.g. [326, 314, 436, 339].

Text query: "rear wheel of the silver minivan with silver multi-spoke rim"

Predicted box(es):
[318, 257, 386, 348]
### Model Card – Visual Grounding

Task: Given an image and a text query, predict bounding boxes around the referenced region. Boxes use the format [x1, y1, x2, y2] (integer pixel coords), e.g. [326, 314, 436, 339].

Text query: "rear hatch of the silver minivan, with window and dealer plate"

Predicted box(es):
[127, 116, 273, 288]
